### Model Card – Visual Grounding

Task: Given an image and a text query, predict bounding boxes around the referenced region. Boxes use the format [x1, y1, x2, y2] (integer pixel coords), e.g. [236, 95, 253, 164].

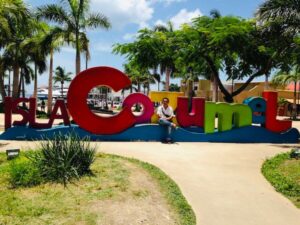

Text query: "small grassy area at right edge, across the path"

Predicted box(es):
[262, 153, 300, 208]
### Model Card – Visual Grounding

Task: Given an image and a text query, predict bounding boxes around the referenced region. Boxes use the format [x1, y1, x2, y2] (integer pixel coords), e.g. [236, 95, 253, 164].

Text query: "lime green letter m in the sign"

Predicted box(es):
[204, 102, 252, 133]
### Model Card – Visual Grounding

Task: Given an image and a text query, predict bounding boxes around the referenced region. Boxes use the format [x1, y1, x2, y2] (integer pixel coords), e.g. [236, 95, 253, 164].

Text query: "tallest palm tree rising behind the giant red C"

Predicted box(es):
[38, 0, 111, 74]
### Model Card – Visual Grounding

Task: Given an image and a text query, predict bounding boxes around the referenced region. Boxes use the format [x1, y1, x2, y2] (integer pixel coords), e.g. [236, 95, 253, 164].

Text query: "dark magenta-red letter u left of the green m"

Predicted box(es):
[176, 97, 205, 127]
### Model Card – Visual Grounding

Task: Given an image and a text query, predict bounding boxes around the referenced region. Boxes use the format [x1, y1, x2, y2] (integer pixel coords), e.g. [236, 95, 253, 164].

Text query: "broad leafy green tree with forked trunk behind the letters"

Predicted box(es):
[176, 16, 293, 102]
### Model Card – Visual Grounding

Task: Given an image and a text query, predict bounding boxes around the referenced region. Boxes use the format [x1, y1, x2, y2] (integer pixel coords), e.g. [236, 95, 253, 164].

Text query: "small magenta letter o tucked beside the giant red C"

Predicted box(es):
[122, 93, 154, 123]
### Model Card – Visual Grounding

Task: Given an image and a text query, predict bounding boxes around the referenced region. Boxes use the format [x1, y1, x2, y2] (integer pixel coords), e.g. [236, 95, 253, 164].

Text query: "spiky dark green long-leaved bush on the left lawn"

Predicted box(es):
[30, 134, 96, 186]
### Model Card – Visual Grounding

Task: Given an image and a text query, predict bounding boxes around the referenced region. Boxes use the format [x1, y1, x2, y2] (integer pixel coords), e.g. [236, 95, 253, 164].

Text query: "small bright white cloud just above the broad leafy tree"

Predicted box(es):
[170, 9, 203, 29]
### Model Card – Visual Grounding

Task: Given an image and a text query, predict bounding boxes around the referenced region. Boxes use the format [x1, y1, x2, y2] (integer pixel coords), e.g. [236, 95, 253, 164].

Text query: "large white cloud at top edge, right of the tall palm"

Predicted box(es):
[91, 0, 154, 29]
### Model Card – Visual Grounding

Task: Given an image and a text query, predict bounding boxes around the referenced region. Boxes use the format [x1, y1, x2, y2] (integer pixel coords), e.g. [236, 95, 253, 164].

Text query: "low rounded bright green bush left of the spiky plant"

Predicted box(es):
[9, 157, 42, 187]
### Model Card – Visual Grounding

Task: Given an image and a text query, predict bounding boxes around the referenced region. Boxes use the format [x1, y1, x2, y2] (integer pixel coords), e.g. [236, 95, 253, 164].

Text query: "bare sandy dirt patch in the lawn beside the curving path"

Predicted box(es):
[92, 162, 179, 225]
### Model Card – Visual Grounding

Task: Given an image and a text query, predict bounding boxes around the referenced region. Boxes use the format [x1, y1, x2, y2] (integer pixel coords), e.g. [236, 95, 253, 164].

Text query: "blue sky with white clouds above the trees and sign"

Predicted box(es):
[25, 0, 263, 93]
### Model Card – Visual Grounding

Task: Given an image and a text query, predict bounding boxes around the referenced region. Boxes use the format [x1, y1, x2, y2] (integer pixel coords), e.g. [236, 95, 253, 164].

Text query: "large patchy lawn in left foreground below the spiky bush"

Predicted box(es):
[0, 153, 196, 225]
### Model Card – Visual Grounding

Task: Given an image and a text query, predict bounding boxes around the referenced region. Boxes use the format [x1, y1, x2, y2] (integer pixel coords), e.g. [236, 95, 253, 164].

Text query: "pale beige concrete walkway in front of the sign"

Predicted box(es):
[0, 141, 300, 225]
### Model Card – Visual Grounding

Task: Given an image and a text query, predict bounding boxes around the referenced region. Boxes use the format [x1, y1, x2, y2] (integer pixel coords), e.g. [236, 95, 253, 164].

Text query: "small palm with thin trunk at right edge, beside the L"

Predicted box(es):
[272, 66, 300, 120]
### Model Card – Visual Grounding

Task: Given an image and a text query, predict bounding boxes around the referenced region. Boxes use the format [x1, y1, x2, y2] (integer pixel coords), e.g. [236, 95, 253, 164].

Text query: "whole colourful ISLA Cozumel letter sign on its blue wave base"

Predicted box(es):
[0, 67, 299, 143]
